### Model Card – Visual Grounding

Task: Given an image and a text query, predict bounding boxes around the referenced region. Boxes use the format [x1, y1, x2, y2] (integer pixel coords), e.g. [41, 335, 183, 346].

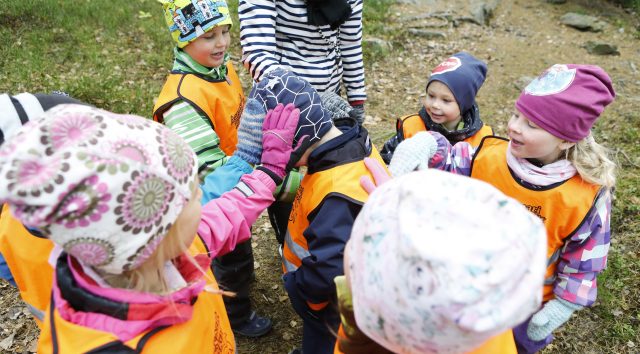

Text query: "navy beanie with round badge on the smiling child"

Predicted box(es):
[426, 52, 487, 115]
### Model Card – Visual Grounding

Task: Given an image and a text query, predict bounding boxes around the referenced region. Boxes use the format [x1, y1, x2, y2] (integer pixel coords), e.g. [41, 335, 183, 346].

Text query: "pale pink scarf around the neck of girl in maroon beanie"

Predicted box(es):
[507, 143, 577, 186]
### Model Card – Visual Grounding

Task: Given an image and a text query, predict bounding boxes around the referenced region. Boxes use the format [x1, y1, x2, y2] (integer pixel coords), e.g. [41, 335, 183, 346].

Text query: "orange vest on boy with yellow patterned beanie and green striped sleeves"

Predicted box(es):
[153, 62, 245, 156]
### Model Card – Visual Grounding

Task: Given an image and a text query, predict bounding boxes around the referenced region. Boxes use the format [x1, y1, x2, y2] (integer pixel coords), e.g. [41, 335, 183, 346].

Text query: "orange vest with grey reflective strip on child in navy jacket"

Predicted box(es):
[282, 147, 385, 273]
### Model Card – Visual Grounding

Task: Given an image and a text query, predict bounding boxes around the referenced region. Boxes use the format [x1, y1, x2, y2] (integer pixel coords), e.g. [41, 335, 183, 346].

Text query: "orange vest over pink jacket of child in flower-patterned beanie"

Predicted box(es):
[38, 237, 235, 354]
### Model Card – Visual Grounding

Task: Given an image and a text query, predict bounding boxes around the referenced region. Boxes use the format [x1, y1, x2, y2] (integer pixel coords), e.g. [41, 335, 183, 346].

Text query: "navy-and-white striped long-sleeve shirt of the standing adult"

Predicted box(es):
[238, 0, 367, 102]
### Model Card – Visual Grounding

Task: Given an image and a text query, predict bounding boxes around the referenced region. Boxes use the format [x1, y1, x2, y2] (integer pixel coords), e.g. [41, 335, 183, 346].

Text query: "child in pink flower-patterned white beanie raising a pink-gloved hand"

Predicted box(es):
[0, 105, 299, 353]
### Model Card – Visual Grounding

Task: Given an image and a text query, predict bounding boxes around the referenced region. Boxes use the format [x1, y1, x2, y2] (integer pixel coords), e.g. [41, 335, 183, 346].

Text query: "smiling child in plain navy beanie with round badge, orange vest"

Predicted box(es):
[380, 52, 493, 164]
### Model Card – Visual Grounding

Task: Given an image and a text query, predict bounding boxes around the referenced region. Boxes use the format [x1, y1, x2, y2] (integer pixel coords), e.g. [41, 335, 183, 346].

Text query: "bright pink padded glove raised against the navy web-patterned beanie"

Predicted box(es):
[259, 103, 300, 184]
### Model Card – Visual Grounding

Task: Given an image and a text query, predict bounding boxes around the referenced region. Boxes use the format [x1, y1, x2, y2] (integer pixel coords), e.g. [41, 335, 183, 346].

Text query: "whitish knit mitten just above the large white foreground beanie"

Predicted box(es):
[389, 132, 438, 177]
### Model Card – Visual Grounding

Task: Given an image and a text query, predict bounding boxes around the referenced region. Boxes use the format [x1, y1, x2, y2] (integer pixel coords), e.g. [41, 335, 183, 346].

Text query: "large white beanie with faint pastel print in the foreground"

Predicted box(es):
[345, 170, 547, 353]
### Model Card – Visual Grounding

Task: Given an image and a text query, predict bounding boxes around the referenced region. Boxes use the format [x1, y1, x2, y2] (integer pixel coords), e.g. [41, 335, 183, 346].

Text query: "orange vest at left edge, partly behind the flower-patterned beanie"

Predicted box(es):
[0, 204, 53, 327]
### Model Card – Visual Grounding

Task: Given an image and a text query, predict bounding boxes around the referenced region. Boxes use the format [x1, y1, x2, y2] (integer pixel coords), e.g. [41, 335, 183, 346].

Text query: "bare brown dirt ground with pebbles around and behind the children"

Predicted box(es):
[0, 0, 640, 354]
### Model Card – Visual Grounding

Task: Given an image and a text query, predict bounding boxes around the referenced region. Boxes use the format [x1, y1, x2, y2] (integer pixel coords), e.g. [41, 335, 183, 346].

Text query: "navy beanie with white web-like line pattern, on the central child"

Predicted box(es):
[249, 68, 333, 146]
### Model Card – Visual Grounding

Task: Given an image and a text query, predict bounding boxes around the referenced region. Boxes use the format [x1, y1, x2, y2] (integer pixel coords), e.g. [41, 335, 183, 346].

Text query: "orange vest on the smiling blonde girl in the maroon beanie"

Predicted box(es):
[471, 136, 600, 301]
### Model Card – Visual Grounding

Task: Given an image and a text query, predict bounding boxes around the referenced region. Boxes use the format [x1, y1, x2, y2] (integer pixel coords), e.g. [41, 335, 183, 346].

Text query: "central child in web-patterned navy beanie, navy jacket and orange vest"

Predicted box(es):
[252, 68, 390, 354]
